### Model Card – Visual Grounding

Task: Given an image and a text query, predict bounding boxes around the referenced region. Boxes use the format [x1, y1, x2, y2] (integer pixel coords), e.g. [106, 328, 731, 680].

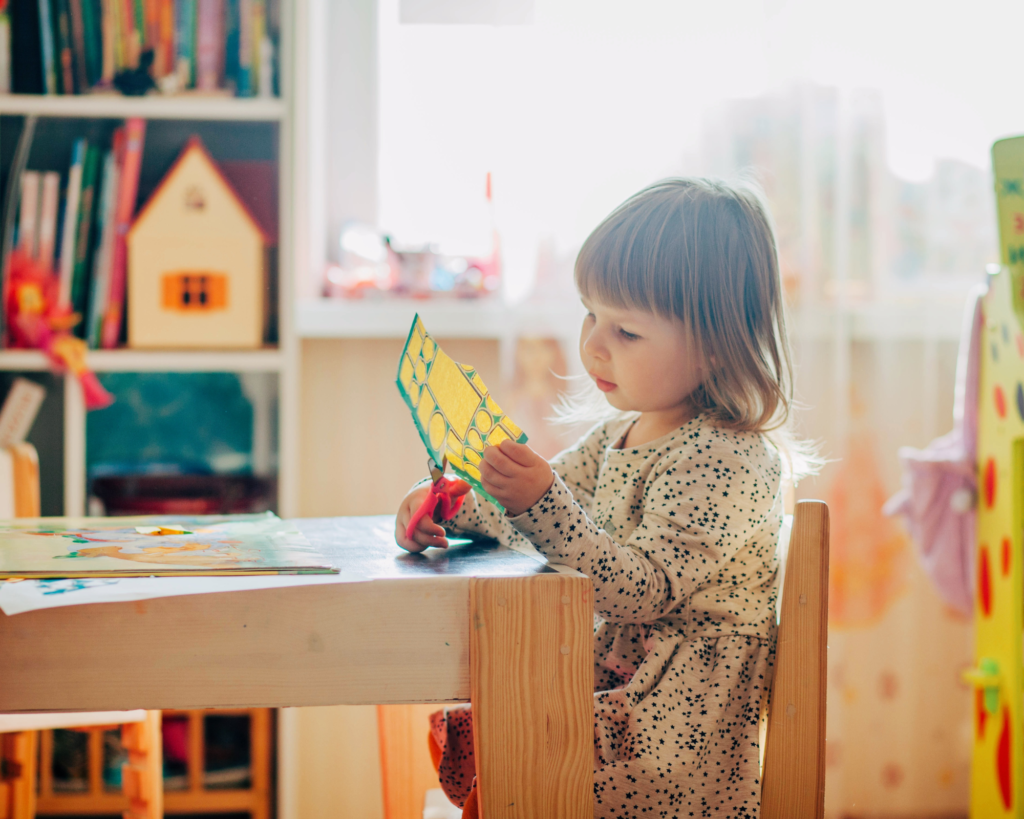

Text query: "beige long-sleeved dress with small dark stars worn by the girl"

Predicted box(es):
[431, 416, 782, 819]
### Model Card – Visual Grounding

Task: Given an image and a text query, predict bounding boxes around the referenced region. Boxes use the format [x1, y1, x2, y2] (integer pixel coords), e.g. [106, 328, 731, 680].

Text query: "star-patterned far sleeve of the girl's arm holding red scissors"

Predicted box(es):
[444, 424, 609, 546]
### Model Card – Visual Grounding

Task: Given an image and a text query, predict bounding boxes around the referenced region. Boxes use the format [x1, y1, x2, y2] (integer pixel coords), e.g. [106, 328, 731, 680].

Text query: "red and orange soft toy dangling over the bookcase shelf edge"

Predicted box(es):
[4, 251, 114, 410]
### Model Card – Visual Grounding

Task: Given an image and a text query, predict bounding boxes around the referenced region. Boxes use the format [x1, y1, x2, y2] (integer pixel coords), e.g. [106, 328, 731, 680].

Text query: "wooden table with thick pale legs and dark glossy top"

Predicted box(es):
[0, 517, 593, 819]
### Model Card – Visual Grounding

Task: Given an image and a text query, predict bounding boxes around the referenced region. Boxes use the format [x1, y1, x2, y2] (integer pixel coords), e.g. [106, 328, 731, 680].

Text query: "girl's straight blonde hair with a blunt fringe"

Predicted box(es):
[563, 178, 813, 477]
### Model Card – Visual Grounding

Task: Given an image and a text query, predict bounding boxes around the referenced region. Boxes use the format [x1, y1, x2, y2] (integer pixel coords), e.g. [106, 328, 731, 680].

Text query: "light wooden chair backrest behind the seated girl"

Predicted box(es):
[761, 501, 828, 819]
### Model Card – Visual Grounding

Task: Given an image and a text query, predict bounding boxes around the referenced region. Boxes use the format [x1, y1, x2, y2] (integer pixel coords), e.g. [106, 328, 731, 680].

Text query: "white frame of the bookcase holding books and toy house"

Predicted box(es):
[0, 24, 298, 517]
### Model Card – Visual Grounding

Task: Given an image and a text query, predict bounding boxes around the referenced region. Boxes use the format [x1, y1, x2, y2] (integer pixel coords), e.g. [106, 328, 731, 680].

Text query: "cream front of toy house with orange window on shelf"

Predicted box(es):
[128, 137, 266, 349]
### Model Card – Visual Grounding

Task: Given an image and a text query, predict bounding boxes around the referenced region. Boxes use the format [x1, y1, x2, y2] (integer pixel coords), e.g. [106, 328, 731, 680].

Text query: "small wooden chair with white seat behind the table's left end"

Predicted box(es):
[0, 442, 164, 819]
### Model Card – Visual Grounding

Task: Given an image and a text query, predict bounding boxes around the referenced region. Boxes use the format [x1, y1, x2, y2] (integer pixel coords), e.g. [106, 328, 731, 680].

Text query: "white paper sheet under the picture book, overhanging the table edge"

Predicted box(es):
[0, 571, 367, 616]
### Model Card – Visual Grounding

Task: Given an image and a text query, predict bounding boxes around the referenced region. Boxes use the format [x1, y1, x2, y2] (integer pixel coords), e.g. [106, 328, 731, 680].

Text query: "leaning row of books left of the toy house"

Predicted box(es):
[14, 119, 145, 349]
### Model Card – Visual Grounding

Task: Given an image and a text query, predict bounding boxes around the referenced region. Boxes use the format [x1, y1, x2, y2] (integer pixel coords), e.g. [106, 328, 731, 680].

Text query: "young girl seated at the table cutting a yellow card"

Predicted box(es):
[396, 179, 792, 819]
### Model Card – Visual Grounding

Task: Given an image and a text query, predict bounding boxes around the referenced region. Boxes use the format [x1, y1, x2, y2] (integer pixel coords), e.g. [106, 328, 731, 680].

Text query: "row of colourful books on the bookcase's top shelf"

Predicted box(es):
[0, 0, 278, 96]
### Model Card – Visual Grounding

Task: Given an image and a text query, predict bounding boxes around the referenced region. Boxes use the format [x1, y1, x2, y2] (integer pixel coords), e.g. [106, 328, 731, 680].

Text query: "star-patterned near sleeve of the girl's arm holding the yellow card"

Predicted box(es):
[508, 448, 778, 622]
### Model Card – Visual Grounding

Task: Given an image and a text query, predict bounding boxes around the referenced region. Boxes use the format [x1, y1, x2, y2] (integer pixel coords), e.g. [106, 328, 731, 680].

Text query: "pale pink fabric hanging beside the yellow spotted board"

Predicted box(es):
[883, 288, 985, 614]
